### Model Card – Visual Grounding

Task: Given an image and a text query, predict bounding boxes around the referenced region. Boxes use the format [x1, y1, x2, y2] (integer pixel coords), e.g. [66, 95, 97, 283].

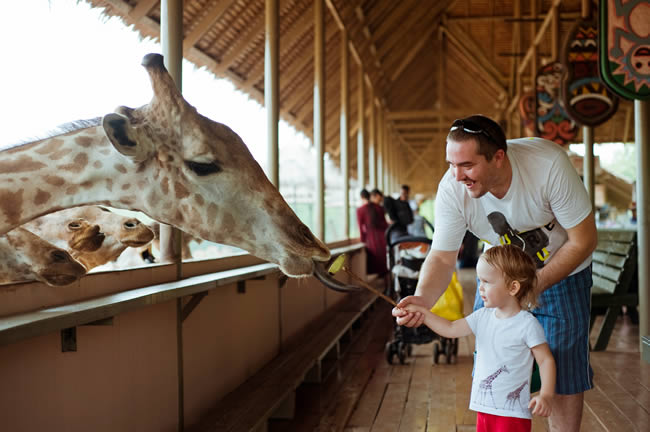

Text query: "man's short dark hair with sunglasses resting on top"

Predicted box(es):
[447, 114, 508, 161]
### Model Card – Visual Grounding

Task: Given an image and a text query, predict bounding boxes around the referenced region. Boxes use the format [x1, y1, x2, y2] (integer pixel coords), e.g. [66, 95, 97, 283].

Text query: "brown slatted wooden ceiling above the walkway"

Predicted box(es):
[89, 0, 633, 190]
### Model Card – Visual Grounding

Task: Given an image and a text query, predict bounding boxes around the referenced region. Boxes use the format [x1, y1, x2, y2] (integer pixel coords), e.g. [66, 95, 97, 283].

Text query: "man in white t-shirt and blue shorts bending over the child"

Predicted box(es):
[393, 115, 597, 431]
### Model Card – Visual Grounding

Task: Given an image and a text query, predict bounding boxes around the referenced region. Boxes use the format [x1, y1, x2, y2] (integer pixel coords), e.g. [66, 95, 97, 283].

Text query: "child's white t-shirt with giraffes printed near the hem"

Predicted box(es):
[465, 308, 546, 419]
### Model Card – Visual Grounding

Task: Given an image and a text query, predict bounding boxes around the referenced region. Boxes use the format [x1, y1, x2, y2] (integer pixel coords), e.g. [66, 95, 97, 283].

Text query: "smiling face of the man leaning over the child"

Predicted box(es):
[447, 139, 509, 198]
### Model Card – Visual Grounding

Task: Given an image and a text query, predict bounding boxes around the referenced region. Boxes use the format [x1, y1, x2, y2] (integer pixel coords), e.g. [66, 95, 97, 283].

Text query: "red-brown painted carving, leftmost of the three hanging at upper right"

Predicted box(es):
[535, 62, 578, 145]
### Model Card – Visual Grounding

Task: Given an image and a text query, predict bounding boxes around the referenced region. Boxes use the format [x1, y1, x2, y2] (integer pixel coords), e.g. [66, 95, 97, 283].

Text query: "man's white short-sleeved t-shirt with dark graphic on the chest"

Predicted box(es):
[432, 138, 591, 274]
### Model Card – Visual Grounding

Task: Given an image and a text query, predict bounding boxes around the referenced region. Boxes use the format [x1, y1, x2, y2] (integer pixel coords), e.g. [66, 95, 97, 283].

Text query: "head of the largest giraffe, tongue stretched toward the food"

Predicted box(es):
[102, 54, 346, 289]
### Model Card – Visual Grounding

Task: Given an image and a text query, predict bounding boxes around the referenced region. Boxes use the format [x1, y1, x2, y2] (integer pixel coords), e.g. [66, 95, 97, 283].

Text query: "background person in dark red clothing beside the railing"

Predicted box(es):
[357, 189, 388, 277]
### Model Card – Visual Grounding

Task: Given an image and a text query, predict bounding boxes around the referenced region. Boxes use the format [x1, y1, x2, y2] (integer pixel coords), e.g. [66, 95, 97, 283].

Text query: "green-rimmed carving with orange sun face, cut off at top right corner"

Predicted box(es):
[599, 0, 650, 100]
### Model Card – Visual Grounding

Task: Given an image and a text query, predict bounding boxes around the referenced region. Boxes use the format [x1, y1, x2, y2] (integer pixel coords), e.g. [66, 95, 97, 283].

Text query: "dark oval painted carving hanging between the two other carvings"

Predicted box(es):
[562, 19, 618, 126]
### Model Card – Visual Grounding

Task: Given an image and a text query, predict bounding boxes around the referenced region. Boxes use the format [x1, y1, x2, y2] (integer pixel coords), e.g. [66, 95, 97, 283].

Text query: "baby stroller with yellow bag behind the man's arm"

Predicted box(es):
[385, 221, 463, 364]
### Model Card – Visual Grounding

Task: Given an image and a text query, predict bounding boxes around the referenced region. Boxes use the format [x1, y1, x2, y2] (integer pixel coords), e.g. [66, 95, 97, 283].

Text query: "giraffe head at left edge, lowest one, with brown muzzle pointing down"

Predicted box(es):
[0, 227, 86, 286]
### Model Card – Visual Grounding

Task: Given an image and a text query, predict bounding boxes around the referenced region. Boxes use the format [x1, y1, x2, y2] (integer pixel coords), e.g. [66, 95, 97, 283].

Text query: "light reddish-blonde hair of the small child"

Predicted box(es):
[481, 245, 537, 309]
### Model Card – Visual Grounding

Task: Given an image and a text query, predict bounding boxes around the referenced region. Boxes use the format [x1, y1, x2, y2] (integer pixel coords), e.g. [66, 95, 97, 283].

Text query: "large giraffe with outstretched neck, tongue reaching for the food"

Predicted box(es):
[0, 54, 351, 290]
